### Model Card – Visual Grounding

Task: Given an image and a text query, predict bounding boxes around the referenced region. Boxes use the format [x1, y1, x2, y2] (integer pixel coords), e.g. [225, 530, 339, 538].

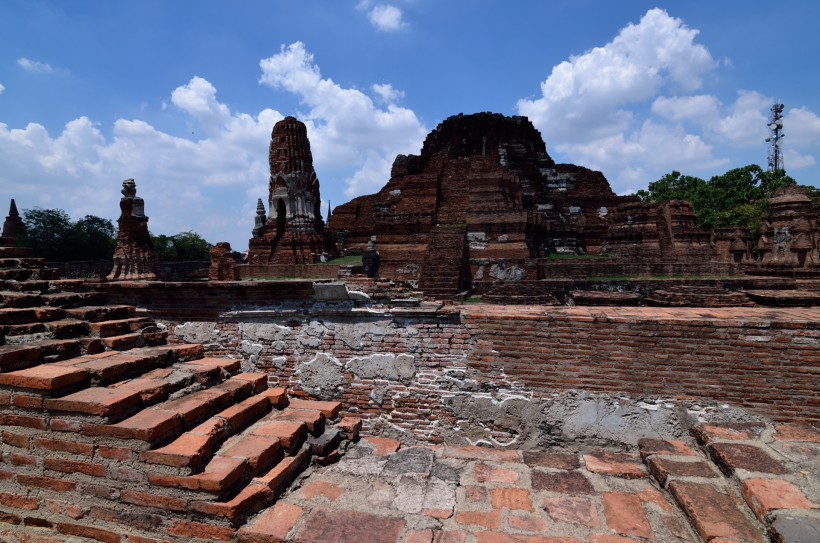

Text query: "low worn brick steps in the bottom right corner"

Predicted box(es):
[639, 423, 820, 543]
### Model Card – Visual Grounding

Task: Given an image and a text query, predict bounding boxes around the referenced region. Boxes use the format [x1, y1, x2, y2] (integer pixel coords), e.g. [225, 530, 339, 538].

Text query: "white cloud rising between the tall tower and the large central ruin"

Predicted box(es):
[260, 42, 427, 197]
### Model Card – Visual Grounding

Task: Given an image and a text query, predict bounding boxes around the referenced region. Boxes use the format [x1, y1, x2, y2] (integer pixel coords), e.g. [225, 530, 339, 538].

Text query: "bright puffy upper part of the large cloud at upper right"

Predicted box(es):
[518, 8, 715, 143]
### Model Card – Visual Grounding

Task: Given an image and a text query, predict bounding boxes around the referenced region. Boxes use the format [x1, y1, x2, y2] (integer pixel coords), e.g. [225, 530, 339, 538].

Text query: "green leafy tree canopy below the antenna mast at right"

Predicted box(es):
[637, 164, 796, 237]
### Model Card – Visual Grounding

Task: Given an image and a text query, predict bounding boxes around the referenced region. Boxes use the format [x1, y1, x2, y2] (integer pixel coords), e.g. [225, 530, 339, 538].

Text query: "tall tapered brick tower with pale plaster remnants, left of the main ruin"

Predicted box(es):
[248, 117, 324, 266]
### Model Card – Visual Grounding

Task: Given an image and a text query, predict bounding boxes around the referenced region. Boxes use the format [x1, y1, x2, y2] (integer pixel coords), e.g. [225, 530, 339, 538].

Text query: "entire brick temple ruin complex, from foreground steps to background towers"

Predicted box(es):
[0, 114, 820, 543]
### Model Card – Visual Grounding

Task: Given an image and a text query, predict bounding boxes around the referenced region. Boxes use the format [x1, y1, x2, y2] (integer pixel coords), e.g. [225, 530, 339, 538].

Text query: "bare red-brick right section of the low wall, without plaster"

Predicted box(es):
[464, 308, 820, 421]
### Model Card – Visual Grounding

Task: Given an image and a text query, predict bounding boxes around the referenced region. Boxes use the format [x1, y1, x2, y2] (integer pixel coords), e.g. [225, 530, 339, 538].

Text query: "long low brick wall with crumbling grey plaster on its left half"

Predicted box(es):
[166, 305, 820, 444]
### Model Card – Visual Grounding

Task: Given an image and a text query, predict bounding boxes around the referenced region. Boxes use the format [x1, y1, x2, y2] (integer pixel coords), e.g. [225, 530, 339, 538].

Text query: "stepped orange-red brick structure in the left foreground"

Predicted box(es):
[0, 240, 361, 543]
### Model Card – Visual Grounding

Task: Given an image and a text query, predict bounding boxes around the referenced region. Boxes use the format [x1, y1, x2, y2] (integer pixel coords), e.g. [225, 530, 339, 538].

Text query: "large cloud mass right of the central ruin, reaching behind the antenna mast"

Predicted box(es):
[518, 8, 820, 192]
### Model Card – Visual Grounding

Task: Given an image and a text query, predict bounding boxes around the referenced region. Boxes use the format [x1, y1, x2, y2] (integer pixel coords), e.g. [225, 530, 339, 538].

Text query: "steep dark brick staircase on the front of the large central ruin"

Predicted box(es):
[419, 224, 467, 299]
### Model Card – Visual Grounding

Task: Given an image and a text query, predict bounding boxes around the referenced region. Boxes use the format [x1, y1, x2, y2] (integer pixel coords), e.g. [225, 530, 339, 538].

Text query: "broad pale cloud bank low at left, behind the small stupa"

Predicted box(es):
[0, 81, 282, 248]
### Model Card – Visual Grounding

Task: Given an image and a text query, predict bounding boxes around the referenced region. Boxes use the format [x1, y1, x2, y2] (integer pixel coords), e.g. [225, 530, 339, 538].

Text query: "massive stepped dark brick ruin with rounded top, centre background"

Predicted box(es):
[328, 113, 727, 296]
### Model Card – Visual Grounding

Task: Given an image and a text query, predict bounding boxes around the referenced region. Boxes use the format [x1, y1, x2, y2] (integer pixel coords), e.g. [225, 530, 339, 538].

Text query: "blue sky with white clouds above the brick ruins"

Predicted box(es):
[0, 0, 820, 250]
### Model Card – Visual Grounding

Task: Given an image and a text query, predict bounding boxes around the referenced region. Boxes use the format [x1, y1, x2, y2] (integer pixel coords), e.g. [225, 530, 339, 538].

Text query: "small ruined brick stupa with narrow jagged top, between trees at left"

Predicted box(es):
[106, 179, 160, 281]
